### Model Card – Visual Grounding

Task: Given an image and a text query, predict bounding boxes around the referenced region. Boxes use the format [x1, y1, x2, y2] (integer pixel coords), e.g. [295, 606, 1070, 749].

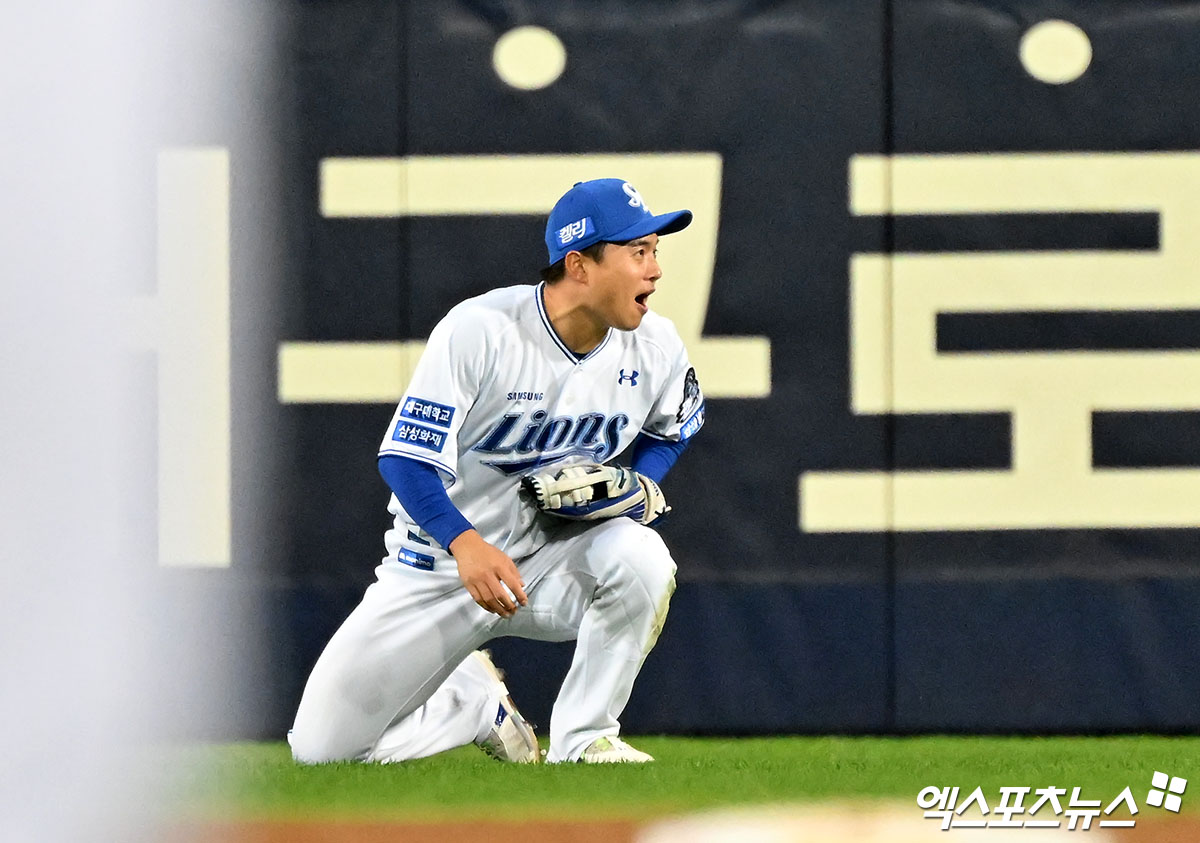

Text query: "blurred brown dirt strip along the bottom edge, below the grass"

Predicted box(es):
[180, 818, 1200, 843]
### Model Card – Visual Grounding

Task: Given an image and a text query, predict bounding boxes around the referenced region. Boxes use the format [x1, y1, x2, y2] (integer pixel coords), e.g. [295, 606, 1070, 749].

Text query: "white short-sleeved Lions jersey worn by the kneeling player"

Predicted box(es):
[379, 285, 704, 569]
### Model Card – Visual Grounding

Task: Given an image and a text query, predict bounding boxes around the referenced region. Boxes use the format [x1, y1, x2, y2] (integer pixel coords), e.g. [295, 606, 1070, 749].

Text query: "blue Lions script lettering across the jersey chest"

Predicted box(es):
[472, 409, 629, 474]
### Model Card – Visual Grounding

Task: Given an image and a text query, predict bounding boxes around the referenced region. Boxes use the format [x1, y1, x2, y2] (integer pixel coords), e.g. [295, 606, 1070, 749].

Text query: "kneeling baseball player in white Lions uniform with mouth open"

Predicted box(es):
[288, 179, 704, 763]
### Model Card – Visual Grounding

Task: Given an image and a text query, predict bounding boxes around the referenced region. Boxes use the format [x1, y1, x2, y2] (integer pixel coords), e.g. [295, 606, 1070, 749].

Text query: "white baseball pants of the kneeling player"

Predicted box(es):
[289, 518, 676, 763]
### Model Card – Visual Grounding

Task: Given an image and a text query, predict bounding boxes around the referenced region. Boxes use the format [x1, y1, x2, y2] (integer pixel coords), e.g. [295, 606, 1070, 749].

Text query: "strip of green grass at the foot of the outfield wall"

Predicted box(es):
[174, 735, 1200, 820]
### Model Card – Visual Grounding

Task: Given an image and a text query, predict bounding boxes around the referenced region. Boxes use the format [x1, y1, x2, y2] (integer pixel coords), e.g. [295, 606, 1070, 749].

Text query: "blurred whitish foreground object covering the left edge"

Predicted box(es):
[0, 0, 274, 842]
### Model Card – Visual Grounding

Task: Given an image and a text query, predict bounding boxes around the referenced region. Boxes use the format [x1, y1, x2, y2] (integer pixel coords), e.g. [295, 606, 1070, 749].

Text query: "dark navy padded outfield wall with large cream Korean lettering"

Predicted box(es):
[160, 0, 1200, 737]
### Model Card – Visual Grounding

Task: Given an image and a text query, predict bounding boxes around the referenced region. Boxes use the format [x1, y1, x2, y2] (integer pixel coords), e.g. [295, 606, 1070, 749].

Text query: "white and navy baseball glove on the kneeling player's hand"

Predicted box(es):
[521, 462, 671, 526]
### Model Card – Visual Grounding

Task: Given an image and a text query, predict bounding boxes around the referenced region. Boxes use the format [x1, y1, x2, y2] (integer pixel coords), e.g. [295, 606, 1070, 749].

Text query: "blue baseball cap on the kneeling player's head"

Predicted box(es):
[546, 179, 691, 264]
